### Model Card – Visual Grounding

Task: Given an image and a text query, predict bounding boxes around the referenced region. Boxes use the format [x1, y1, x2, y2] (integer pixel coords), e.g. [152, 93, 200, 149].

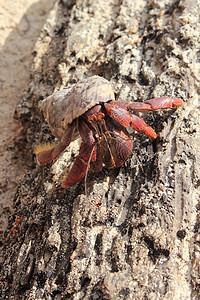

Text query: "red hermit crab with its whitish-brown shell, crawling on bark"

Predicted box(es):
[35, 76, 183, 188]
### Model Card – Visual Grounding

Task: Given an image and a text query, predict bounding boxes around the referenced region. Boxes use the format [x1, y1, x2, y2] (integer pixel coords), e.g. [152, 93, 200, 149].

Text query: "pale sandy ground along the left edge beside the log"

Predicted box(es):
[0, 0, 55, 241]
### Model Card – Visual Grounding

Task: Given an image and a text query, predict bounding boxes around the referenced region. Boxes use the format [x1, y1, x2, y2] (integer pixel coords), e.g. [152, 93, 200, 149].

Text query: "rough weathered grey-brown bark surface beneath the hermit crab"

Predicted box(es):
[1, 0, 200, 299]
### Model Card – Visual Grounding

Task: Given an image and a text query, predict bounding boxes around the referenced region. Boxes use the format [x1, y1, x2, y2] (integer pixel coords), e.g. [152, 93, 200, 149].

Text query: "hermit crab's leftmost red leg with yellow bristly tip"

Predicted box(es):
[35, 122, 75, 165]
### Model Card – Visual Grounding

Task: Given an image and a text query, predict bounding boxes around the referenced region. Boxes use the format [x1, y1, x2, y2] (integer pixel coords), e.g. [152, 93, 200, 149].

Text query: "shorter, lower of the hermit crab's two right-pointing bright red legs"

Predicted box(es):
[104, 103, 157, 139]
